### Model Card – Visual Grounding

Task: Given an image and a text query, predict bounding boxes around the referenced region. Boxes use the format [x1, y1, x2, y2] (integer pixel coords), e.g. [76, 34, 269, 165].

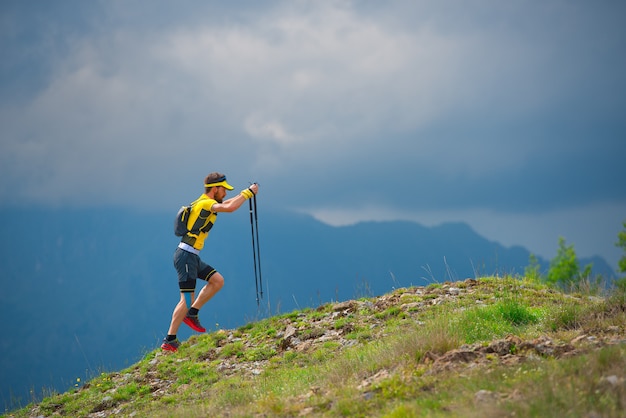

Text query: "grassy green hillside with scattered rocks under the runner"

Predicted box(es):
[8, 277, 626, 418]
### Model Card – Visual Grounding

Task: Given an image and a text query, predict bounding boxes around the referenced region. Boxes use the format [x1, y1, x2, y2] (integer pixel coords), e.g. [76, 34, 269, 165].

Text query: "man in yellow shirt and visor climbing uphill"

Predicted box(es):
[161, 173, 259, 351]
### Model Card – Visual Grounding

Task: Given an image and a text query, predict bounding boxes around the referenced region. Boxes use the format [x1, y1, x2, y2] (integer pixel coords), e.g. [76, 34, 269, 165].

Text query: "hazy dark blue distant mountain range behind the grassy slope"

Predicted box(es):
[0, 208, 614, 408]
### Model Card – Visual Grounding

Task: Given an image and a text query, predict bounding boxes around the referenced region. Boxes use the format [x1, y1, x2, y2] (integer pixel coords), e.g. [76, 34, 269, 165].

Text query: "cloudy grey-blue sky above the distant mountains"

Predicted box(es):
[0, 0, 626, 269]
